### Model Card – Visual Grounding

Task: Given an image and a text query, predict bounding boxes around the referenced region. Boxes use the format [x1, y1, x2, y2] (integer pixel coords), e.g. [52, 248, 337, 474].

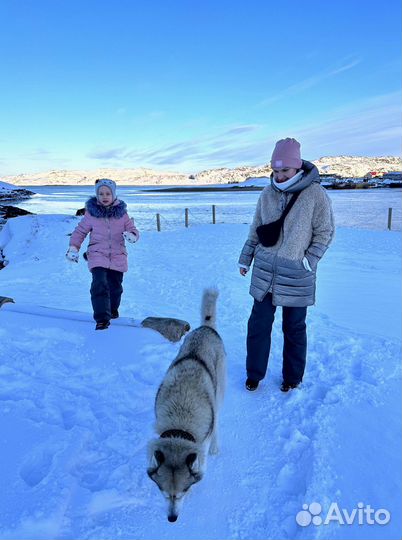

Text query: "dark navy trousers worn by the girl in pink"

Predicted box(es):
[91, 266, 123, 322]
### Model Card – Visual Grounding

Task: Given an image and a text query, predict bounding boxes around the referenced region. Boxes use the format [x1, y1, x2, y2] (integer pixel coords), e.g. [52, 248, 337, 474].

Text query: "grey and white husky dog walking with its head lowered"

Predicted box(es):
[147, 289, 225, 522]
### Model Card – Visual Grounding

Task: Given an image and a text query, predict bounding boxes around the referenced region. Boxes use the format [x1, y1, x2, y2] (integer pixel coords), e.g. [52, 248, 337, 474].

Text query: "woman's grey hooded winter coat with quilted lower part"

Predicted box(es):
[239, 161, 334, 307]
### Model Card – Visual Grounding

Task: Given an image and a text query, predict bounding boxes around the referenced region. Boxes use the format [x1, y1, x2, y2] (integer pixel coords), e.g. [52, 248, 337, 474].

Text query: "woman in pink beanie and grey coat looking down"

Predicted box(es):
[239, 138, 334, 392]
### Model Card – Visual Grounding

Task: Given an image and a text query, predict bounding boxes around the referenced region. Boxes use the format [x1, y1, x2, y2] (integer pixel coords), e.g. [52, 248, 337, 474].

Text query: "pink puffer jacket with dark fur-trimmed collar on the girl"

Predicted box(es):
[70, 197, 140, 272]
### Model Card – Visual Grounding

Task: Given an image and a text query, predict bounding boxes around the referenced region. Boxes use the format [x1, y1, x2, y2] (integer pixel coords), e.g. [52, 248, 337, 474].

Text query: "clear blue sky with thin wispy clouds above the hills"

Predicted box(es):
[0, 0, 402, 175]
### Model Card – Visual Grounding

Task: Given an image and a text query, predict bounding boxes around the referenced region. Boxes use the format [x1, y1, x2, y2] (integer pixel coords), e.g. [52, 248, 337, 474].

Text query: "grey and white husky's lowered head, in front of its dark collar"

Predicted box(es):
[147, 438, 204, 522]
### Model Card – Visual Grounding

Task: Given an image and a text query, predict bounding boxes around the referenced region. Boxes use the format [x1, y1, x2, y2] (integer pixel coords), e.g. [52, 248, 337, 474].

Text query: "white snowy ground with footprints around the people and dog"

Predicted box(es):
[0, 215, 402, 540]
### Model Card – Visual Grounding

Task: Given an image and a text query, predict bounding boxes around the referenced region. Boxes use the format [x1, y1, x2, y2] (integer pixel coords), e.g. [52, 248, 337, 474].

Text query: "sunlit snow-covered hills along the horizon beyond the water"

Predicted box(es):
[5, 156, 402, 186]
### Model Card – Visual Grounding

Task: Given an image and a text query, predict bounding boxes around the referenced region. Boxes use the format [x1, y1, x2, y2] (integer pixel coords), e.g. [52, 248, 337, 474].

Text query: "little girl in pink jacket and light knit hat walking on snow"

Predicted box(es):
[66, 178, 140, 330]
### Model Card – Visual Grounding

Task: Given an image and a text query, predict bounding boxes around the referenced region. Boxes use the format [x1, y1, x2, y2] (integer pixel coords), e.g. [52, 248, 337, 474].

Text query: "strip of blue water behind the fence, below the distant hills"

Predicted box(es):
[11, 186, 402, 230]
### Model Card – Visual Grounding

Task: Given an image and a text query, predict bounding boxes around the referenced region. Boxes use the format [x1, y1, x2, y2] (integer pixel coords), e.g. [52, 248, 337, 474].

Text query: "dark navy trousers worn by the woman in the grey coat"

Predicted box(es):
[246, 294, 307, 384]
